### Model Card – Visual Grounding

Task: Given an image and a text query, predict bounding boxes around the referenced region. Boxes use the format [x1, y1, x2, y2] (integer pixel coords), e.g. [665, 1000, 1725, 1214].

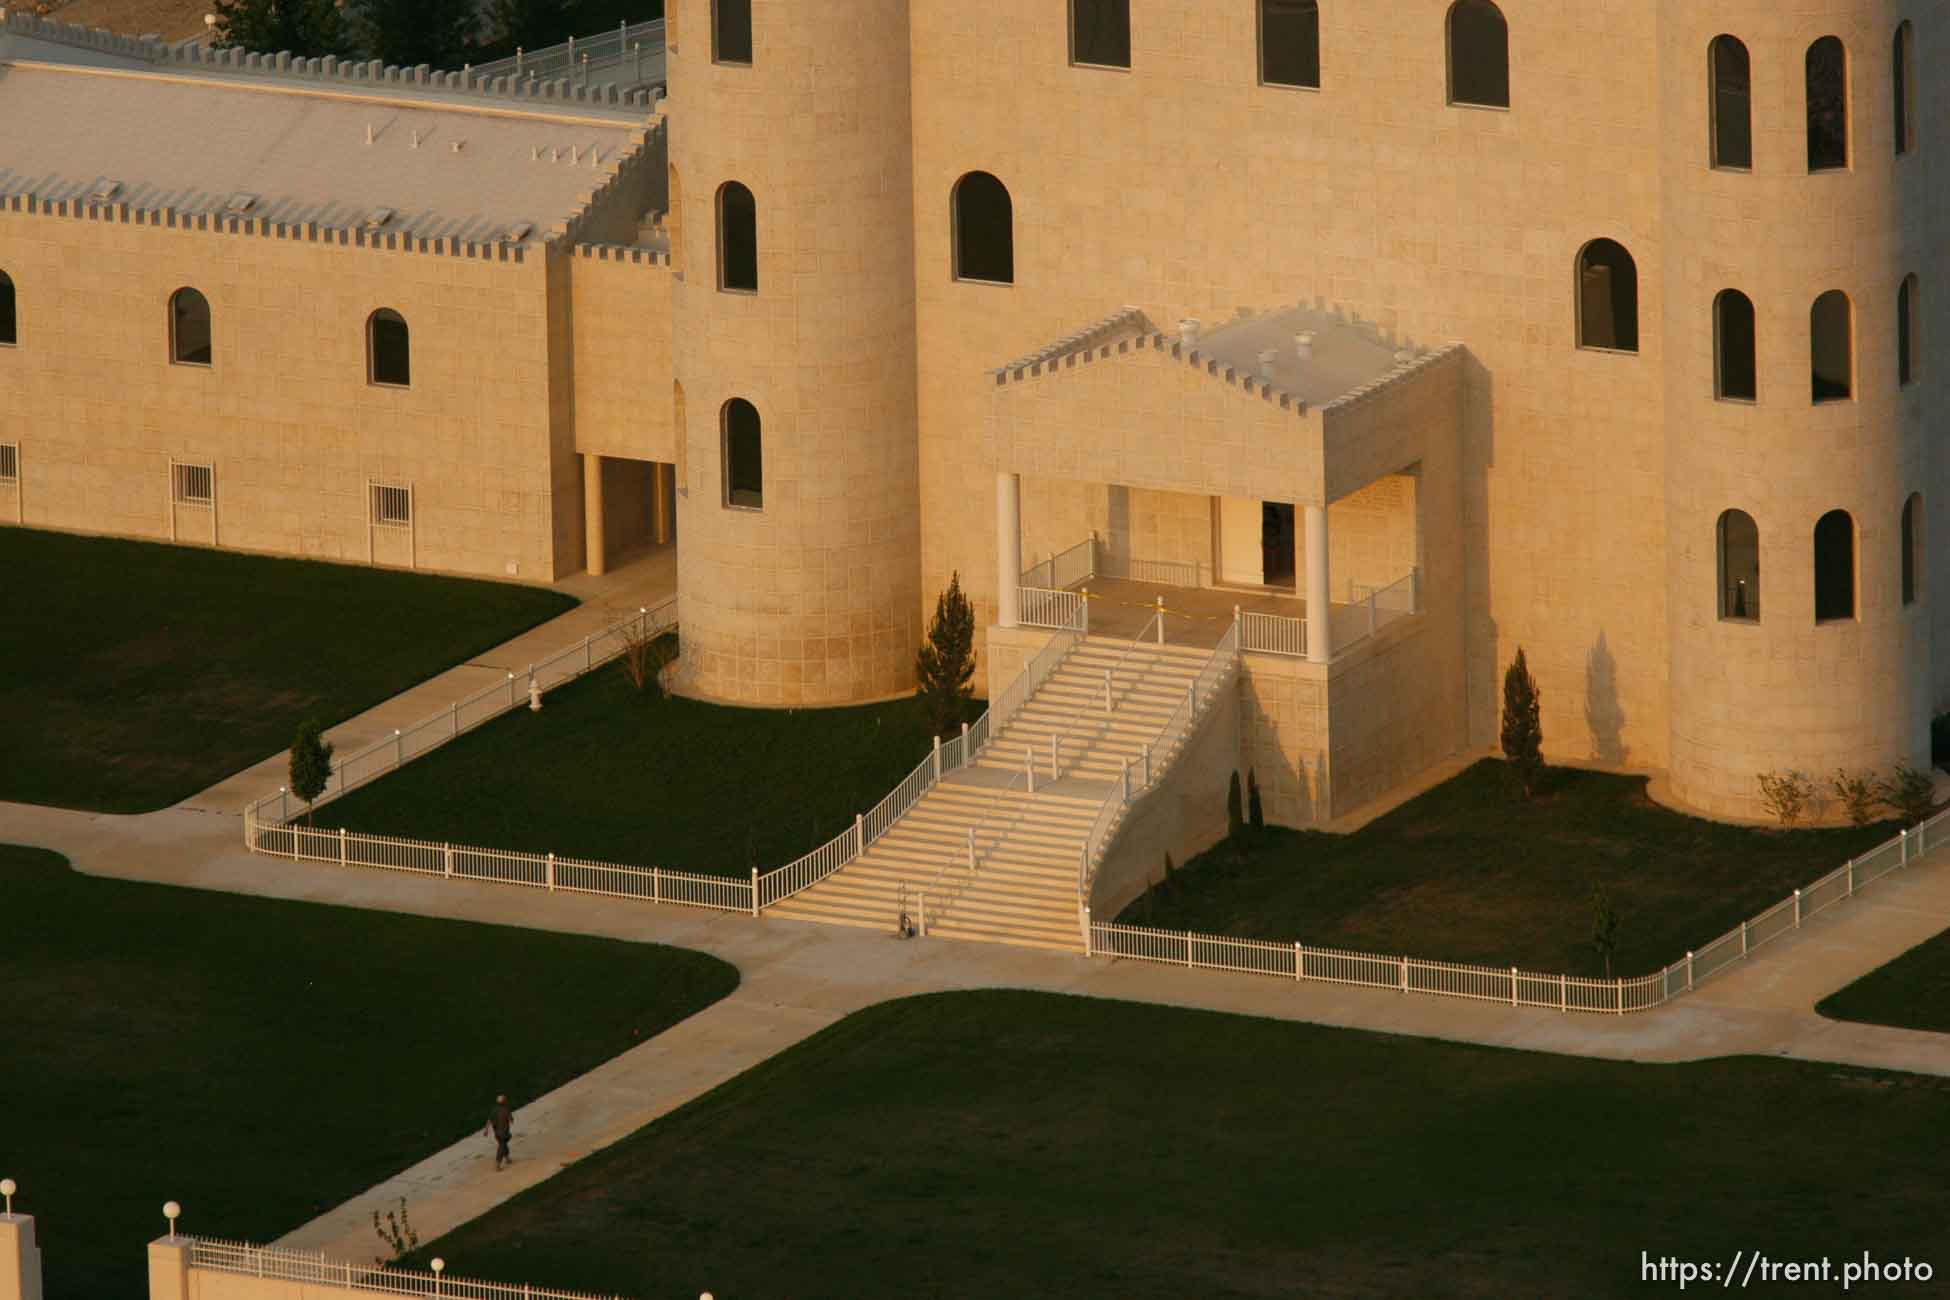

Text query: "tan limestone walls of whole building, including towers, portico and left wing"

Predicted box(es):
[0, 0, 1950, 822]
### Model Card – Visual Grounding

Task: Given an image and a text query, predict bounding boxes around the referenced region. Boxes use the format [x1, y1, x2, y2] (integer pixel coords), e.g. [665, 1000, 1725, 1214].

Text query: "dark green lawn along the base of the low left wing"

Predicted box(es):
[0, 528, 575, 813]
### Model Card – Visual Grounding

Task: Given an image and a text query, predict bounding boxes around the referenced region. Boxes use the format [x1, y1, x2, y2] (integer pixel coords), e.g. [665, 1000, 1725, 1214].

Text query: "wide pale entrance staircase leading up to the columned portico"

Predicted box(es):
[766, 639, 1211, 949]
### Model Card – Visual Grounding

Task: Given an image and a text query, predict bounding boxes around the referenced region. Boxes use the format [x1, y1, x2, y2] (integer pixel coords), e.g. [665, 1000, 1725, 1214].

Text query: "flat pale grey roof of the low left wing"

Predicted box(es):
[0, 60, 644, 242]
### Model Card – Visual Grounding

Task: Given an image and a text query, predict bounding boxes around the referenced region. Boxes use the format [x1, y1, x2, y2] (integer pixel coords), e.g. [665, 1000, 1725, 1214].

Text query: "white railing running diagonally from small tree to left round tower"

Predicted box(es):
[250, 596, 677, 822]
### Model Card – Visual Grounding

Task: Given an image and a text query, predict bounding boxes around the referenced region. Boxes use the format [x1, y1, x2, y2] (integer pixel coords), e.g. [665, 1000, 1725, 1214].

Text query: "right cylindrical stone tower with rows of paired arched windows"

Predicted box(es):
[1659, 0, 1950, 817]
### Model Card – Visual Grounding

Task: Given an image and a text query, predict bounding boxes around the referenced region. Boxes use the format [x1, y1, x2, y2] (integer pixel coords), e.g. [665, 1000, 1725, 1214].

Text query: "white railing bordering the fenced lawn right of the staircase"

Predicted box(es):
[1084, 809, 1950, 1015]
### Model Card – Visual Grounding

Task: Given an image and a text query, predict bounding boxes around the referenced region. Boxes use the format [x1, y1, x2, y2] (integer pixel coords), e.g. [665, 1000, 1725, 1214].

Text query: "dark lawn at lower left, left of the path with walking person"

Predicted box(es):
[0, 846, 737, 1300]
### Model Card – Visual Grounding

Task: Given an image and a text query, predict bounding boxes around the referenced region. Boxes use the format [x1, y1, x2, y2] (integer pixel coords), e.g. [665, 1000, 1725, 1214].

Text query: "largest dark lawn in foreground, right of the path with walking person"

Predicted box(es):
[421, 992, 1950, 1300]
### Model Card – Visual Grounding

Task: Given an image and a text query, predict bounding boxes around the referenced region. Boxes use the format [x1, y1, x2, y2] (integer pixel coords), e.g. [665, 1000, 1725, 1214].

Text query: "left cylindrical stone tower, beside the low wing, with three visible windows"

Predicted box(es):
[653, 0, 920, 706]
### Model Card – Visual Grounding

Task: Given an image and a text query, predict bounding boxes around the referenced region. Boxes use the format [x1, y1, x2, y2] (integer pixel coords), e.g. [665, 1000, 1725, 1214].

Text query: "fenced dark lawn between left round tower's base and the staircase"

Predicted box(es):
[318, 665, 955, 875]
